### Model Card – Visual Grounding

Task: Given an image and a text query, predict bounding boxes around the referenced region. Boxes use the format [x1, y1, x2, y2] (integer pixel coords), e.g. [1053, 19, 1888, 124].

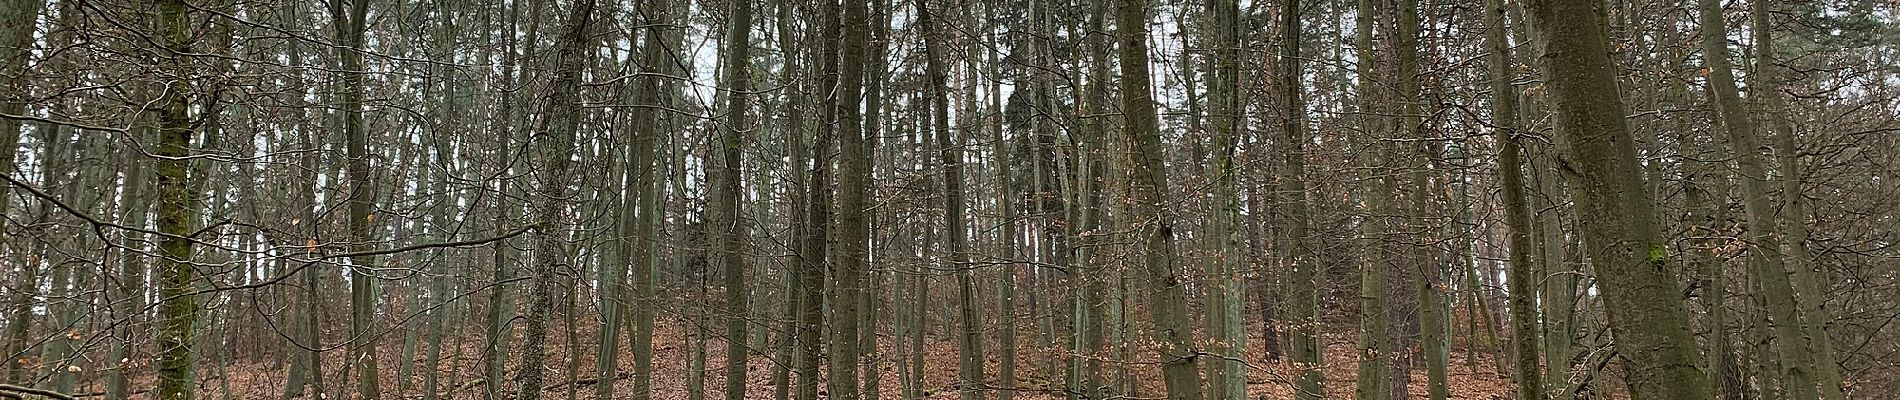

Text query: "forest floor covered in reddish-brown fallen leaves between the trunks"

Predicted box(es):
[80, 320, 1511, 400]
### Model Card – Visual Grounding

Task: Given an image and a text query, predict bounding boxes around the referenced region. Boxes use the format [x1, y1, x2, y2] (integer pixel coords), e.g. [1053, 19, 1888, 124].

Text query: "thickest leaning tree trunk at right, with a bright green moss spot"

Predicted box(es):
[1530, 0, 1710, 400]
